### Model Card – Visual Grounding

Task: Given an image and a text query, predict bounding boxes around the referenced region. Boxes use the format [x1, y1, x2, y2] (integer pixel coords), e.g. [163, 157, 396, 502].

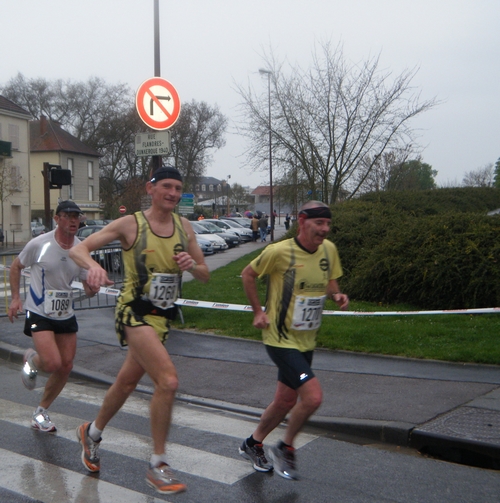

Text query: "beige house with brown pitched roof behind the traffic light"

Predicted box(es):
[30, 116, 102, 222]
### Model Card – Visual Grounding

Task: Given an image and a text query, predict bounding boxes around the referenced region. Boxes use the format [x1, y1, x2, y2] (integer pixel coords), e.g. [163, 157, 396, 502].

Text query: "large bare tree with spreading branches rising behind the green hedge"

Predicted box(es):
[236, 44, 437, 202]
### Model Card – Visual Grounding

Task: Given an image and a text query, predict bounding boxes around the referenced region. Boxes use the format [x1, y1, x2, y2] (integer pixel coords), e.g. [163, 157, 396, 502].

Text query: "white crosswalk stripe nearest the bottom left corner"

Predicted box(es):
[0, 448, 165, 503]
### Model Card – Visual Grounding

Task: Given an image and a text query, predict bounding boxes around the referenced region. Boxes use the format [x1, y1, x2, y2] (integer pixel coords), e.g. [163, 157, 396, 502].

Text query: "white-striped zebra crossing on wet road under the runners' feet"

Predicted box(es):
[0, 383, 317, 503]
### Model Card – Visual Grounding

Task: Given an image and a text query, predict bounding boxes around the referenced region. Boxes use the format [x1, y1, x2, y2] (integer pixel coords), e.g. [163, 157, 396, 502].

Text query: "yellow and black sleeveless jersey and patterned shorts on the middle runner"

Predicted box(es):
[116, 211, 188, 345]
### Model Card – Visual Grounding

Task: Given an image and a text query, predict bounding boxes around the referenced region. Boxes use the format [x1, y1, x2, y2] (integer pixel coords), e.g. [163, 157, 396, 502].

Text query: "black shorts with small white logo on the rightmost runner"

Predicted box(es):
[266, 346, 314, 389]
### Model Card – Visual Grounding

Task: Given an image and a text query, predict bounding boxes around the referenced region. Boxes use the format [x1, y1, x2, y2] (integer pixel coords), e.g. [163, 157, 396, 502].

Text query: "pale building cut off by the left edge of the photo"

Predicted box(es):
[0, 96, 32, 244]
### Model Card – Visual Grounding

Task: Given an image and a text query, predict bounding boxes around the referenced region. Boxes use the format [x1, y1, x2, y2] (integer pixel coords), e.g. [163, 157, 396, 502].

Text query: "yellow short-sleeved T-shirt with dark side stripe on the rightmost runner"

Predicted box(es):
[250, 238, 342, 352]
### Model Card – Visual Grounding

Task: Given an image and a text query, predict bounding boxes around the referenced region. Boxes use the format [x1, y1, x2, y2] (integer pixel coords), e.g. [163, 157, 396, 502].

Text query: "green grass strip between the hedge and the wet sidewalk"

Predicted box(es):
[173, 250, 500, 365]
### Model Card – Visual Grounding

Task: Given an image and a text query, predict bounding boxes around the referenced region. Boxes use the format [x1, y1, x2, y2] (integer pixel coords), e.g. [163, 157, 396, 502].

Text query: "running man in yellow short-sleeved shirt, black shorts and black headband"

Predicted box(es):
[239, 201, 349, 480]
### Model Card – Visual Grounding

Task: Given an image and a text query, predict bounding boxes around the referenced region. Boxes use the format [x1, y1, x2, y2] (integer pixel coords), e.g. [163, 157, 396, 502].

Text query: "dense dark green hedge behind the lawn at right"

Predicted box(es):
[331, 188, 500, 309]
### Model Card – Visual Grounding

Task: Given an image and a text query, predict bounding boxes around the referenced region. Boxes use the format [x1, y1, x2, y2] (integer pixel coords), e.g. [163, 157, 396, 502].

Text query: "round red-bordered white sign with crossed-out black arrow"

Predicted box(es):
[135, 77, 181, 130]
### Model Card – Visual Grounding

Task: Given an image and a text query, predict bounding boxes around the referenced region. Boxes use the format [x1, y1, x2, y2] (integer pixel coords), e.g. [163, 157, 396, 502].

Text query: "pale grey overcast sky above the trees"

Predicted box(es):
[0, 0, 500, 186]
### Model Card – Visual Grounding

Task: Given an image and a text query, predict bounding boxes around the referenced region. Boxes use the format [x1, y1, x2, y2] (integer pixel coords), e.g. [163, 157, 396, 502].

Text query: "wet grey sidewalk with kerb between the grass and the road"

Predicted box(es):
[0, 226, 500, 469]
